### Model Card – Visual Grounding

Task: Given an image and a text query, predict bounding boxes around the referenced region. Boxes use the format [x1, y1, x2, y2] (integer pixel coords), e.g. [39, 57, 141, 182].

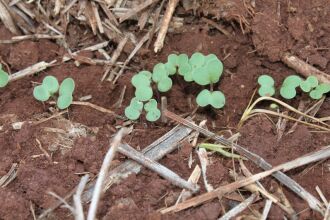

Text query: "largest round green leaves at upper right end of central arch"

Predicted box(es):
[189, 53, 223, 86]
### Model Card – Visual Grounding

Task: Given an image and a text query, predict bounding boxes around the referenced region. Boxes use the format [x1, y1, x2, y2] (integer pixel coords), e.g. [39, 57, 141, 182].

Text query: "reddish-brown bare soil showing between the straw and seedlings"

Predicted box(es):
[0, 0, 330, 220]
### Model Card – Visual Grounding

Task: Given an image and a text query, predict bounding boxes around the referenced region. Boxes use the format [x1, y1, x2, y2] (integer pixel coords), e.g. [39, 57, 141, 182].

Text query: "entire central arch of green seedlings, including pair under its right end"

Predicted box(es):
[125, 52, 225, 121]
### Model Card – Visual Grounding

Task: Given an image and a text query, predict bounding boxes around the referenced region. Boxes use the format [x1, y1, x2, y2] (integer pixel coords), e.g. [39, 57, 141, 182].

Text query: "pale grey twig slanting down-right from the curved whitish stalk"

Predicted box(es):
[118, 145, 199, 193]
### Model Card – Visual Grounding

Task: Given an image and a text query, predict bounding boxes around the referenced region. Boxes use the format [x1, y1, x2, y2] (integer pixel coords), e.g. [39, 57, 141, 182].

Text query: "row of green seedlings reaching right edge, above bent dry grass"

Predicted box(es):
[258, 75, 330, 99]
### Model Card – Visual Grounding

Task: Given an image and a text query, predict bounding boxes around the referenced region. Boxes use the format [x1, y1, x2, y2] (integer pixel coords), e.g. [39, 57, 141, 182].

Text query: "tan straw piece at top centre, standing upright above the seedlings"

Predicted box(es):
[154, 0, 179, 53]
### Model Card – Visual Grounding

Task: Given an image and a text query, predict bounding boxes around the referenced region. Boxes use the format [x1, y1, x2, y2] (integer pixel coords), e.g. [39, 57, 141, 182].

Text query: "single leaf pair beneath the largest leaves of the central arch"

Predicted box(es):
[196, 89, 226, 109]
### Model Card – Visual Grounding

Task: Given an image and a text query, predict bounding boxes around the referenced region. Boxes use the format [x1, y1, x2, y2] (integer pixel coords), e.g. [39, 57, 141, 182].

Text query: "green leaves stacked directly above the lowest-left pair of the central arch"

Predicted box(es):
[131, 71, 153, 102]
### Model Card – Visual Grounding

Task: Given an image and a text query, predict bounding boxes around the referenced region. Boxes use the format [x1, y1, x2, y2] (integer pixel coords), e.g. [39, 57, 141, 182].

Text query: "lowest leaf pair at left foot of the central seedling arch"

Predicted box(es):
[125, 97, 161, 122]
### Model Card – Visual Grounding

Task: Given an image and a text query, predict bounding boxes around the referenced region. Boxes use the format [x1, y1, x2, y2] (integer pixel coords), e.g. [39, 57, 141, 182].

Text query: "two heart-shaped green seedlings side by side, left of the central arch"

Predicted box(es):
[33, 76, 75, 109]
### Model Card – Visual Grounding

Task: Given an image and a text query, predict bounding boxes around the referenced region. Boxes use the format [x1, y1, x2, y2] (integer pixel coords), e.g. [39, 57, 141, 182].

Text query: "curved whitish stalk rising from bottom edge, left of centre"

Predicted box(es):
[87, 128, 126, 220]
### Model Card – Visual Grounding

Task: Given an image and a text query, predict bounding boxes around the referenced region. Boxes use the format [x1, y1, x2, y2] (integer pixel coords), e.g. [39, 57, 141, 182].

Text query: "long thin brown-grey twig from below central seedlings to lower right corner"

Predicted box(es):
[163, 111, 324, 213]
